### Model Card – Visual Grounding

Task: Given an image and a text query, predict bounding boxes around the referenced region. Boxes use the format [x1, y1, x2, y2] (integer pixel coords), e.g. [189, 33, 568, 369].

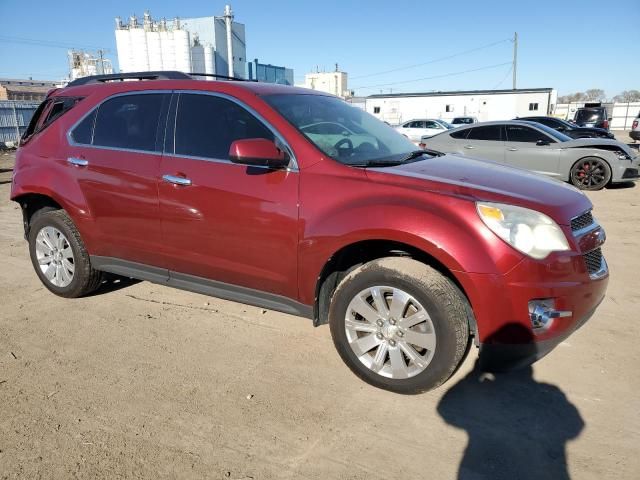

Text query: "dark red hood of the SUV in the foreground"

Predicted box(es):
[367, 154, 592, 225]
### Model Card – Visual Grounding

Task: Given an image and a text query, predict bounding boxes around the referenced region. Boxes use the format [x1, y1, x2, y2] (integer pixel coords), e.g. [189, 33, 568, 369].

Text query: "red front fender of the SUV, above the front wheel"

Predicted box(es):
[299, 176, 522, 304]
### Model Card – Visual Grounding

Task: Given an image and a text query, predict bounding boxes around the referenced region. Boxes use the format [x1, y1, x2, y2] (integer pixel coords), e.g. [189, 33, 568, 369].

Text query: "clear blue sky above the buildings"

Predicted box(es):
[0, 0, 640, 96]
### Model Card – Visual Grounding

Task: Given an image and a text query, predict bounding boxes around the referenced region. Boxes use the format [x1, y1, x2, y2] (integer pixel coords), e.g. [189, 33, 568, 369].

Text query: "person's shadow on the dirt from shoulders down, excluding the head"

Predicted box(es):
[438, 324, 584, 480]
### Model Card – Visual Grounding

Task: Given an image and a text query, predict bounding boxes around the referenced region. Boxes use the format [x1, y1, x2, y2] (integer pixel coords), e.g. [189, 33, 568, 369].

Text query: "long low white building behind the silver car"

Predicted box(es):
[365, 88, 558, 124]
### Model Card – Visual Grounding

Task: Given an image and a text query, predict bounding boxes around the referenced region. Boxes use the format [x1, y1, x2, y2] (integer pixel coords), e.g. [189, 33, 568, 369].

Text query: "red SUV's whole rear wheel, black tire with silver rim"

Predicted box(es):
[28, 210, 102, 298]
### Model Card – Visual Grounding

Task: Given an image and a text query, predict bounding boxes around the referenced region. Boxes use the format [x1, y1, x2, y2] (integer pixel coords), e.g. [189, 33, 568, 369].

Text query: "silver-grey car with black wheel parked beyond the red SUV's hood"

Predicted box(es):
[420, 121, 640, 190]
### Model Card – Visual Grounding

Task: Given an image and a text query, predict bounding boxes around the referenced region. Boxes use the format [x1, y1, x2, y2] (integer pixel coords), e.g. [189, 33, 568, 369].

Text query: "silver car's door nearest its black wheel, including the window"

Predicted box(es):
[505, 125, 561, 178]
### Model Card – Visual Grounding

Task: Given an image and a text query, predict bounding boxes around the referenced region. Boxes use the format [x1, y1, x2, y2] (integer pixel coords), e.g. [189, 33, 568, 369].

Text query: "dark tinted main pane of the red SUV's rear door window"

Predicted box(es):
[94, 93, 165, 151]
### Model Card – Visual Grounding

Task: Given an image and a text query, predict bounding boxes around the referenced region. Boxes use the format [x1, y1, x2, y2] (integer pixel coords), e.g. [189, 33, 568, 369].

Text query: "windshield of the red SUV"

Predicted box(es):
[263, 94, 426, 166]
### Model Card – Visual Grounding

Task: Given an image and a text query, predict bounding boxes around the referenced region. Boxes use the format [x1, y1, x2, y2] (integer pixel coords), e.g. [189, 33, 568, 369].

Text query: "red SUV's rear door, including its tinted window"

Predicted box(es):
[67, 91, 170, 266]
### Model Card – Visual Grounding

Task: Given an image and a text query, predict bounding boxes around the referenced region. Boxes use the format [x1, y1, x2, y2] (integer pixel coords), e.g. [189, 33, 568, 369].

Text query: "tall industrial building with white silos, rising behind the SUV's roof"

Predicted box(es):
[115, 5, 246, 78]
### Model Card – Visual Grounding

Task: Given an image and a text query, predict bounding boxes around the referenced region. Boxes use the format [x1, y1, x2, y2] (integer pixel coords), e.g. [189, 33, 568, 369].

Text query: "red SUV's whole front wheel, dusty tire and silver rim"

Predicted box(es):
[329, 257, 471, 394]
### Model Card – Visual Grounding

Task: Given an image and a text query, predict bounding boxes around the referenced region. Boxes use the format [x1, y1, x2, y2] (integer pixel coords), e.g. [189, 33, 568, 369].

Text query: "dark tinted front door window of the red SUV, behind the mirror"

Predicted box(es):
[175, 94, 274, 160]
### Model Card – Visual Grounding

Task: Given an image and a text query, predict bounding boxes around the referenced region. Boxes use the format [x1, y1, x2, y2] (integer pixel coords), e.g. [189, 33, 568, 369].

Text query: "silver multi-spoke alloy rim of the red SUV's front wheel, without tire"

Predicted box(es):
[345, 286, 436, 379]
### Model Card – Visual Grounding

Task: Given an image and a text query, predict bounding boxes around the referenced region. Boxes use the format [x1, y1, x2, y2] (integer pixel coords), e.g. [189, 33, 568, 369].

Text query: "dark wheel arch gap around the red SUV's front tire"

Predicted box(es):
[313, 239, 478, 338]
